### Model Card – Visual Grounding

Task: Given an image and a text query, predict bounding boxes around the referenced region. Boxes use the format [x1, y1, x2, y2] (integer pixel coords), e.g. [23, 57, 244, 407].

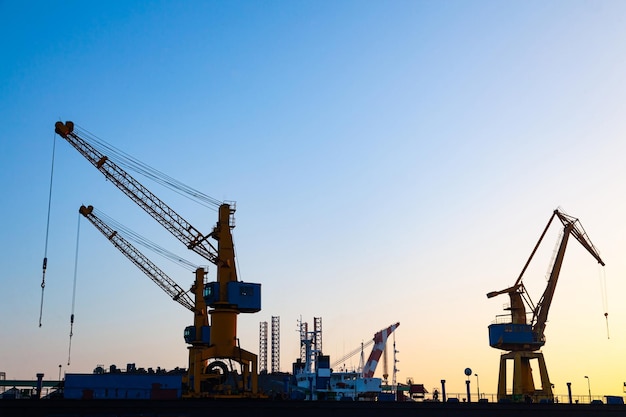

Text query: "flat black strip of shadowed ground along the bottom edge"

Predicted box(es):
[0, 399, 626, 417]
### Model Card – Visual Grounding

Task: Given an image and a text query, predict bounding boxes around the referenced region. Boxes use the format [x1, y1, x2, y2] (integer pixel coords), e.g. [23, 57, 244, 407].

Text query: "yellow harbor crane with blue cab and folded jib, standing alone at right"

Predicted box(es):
[487, 209, 604, 402]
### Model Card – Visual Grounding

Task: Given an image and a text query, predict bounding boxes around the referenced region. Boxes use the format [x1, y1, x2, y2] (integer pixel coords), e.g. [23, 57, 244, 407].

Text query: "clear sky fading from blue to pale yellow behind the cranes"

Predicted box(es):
[0, 0, 626, 402]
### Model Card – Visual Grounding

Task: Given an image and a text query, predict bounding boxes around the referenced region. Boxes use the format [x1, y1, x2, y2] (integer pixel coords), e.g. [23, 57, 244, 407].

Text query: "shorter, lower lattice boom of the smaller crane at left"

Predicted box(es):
[78, 206, 196, 312]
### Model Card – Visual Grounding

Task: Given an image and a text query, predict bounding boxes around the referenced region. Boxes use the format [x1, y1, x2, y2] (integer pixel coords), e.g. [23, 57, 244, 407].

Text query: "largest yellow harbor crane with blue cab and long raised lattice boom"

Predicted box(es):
[55, 121, 261, 398]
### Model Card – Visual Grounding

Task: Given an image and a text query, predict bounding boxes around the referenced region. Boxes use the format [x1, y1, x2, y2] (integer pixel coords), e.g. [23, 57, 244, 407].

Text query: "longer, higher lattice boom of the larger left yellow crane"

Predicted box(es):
[55, 121, 219, 265]
